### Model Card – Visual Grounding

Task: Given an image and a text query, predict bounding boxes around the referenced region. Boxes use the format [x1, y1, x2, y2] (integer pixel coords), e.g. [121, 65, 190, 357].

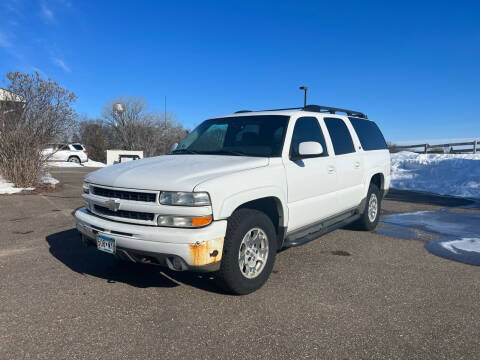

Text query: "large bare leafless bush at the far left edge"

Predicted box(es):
[0, 72, 76, 187]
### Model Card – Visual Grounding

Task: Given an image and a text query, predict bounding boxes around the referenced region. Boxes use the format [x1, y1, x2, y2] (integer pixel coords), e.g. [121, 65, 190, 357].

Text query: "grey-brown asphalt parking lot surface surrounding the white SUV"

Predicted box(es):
[0, 168, 480, 359]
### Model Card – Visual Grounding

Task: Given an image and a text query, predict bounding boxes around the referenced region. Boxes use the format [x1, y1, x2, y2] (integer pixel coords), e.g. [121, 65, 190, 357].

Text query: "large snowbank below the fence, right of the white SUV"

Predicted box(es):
[391, 151, 480, 199]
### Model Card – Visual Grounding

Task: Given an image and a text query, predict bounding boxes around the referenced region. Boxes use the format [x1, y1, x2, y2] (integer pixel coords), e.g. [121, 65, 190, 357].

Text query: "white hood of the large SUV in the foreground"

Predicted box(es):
[85, 155, 269, 191]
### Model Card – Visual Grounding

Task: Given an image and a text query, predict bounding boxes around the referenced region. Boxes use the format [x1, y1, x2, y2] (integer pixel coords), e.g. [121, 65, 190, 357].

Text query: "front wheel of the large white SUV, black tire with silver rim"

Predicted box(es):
[217, 209, 277, 295]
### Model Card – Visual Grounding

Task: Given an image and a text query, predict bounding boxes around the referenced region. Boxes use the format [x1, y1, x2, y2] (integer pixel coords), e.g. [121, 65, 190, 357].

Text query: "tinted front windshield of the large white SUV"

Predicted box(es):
[172, 115, 289, 157]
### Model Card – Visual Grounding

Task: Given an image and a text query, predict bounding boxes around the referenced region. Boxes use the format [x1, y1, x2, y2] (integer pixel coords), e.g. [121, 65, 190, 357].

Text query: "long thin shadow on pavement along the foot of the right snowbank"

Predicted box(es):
[385, 189, 475, 207]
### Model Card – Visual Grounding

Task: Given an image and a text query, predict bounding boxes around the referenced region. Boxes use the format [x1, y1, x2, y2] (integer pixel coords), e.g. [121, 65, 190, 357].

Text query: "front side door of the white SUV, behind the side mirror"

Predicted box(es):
[284, 117, 337, 231]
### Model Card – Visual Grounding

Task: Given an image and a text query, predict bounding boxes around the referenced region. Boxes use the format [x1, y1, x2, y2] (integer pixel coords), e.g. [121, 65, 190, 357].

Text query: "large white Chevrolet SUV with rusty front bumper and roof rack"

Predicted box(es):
[75, 105, 390, 294]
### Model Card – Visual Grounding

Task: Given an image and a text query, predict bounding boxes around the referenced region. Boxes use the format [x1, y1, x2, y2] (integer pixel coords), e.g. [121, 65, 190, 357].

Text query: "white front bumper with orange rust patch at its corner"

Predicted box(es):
[75, 208, 227, 271]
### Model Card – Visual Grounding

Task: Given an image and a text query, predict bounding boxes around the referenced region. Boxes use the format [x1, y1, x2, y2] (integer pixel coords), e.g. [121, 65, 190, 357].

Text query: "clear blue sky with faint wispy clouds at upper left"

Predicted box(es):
[0, 0, 480, 141]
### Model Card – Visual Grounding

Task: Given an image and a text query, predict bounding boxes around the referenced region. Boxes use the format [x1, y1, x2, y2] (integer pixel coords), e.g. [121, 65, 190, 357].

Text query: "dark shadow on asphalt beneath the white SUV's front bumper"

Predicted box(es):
[46, 229, 227, 293]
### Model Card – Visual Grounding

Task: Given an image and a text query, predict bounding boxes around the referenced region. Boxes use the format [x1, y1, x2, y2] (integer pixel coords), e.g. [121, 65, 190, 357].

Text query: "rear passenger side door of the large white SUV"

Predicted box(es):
[324, 117, 363, 211]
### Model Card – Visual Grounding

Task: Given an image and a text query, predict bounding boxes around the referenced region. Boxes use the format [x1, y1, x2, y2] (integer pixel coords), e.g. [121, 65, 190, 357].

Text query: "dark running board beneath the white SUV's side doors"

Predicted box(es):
[283, 209, 361, 248]
